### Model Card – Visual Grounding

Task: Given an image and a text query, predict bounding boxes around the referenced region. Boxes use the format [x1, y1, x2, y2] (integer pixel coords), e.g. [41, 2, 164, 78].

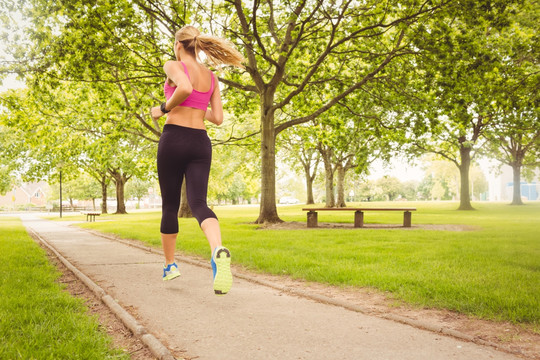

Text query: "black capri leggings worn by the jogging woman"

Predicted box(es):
[157, 124, 217, 234]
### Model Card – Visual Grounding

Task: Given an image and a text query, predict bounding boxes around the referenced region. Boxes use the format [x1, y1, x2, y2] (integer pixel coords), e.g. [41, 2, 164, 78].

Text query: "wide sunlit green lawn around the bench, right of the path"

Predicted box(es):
[74, 202, 540, 331]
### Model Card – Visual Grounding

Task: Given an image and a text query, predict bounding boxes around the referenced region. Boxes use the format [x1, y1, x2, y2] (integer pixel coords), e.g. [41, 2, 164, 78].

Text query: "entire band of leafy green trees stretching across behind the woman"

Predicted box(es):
[0, 0, 540, 222]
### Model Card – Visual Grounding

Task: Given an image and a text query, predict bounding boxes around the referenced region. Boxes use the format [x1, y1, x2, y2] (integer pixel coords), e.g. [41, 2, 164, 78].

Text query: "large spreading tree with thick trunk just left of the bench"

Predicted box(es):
[219, 0, 447, 223]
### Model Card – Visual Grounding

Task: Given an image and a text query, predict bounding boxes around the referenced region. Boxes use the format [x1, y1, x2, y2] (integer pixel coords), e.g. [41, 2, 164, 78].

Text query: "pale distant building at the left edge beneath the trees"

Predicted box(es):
[0, 182, 49, 210]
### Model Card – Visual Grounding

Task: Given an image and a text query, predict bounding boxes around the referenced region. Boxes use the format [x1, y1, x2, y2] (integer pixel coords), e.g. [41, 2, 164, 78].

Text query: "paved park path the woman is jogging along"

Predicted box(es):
[17, 214, 518, 360]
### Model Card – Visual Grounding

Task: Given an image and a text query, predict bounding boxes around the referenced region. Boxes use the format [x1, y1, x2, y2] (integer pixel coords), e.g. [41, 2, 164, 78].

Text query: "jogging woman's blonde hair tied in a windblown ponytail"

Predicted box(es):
[175, 25, 244, 68]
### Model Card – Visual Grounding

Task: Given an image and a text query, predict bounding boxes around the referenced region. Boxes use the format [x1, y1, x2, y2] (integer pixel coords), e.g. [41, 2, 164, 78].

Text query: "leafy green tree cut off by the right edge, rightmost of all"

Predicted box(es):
[484, 1, 540, 205]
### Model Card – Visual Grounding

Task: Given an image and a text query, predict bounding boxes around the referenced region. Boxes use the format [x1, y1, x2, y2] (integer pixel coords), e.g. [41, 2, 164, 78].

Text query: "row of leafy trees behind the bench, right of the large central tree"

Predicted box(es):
[278, 3, 540, 209]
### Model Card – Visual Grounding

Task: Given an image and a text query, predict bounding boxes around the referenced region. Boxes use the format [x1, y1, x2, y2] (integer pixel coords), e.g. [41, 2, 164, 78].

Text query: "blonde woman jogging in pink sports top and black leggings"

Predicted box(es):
[151, 26, 243, 295]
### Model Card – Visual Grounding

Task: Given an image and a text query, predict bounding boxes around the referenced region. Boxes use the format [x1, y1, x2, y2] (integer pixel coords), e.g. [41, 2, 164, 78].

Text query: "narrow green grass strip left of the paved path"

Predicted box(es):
[0, 217, 129, 359]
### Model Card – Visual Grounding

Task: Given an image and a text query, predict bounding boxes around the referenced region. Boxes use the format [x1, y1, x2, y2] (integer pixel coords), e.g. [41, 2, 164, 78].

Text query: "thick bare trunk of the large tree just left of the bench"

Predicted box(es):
[255, 102, 283, 224]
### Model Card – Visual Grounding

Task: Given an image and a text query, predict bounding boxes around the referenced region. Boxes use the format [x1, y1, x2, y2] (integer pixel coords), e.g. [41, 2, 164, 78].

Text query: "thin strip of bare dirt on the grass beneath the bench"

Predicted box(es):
[259, 221, 480, 231]
